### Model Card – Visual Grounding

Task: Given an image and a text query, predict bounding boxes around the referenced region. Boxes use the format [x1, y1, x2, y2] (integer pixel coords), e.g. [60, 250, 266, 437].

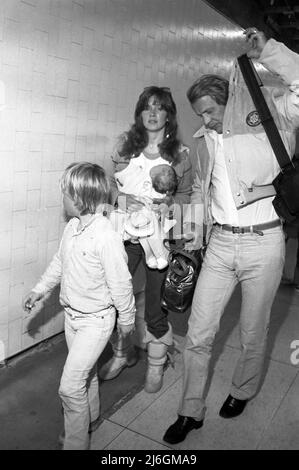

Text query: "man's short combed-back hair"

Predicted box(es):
[187, 74, 229, 106]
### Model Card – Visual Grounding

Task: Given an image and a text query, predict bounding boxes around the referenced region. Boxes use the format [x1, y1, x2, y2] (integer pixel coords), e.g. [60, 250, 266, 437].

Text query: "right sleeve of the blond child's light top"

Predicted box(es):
[99, 231, 136, 325]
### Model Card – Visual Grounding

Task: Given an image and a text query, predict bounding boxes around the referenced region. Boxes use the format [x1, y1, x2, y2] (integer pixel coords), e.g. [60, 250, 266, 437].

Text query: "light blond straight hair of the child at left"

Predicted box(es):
[60, 162, 110, 215]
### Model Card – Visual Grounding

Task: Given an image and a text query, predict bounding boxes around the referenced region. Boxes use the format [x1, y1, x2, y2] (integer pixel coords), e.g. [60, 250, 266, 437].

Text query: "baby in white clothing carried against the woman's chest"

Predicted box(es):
[110, 159, 178, 269]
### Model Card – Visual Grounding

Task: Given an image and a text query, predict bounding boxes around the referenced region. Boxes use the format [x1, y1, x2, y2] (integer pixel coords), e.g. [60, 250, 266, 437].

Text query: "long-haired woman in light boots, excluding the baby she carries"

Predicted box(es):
[100, 86, 192, 393]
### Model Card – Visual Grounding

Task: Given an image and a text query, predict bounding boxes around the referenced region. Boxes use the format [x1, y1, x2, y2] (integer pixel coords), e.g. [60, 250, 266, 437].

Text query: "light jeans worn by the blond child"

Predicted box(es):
[59, 309, 115, 450]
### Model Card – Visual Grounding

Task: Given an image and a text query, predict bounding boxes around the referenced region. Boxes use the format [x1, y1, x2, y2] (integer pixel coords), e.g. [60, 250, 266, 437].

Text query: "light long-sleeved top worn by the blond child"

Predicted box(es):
[33, 214, 136, 325]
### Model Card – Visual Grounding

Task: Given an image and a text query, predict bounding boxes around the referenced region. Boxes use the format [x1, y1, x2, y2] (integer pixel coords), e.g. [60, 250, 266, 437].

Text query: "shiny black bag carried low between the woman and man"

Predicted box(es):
[161, 244, 204, 313]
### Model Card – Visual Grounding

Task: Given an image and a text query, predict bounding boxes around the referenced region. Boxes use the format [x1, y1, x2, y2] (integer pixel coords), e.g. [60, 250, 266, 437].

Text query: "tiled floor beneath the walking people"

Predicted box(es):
[0, 285, 299, 450]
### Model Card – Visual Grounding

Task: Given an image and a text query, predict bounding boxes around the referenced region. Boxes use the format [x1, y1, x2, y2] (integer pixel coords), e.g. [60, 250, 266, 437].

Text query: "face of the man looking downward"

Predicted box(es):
[191, 95, 225, 134]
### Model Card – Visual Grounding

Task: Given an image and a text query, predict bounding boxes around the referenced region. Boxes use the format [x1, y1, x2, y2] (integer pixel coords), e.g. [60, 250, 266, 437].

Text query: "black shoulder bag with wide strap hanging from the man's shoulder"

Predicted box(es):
[238, 54, 299, 222]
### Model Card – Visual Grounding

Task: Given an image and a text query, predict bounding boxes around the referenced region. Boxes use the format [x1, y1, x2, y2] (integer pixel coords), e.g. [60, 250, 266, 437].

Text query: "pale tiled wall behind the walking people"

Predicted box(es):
[0, 0, 246, 362]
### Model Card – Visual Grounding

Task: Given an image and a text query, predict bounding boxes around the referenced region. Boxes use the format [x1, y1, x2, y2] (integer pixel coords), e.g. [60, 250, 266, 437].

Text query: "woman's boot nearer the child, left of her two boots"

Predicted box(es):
[99, 335, 138, 380]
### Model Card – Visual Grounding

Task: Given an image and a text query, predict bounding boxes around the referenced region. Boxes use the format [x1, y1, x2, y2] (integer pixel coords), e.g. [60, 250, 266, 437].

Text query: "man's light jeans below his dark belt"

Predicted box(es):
[178, 226, 285, 419]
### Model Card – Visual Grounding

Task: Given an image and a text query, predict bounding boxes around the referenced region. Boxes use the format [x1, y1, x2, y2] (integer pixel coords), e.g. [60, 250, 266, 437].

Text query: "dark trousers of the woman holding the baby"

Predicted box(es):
[125, 242, 169, 339]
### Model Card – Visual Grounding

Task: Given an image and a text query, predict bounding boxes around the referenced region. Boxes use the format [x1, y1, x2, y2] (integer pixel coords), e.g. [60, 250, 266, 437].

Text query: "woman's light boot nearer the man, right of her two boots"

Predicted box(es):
[144, 324, 173, 393]
